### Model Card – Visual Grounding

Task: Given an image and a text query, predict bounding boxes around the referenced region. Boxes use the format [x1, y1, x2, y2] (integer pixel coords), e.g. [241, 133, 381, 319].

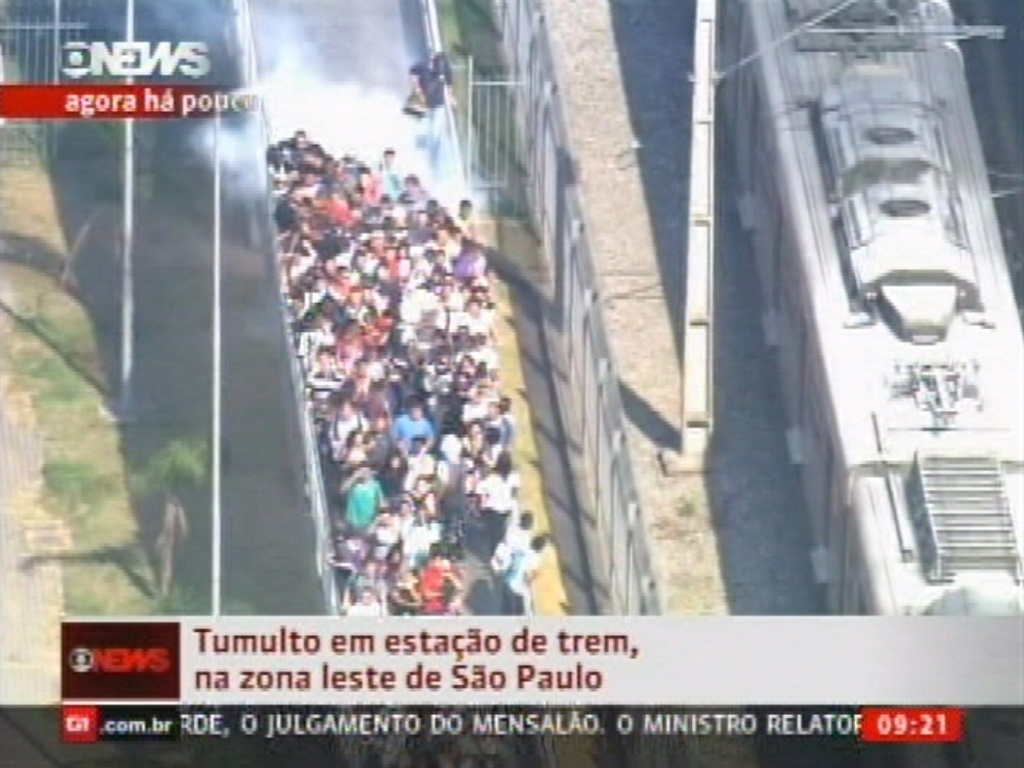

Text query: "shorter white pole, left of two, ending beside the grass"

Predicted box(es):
[117, 0, 135, 421]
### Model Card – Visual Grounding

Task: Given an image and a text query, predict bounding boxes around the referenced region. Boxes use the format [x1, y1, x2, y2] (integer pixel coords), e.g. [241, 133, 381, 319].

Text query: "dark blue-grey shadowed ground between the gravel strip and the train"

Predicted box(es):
[608, 0, 820, 614]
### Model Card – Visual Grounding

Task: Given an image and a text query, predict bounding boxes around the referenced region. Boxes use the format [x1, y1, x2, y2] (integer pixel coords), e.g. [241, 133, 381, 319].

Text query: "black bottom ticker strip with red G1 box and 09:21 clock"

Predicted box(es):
[60, 703, 967, 743]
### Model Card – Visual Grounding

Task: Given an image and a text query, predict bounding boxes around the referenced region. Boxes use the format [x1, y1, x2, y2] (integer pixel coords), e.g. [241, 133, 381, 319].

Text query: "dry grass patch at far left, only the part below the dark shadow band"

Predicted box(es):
[2, 264, 155, 615]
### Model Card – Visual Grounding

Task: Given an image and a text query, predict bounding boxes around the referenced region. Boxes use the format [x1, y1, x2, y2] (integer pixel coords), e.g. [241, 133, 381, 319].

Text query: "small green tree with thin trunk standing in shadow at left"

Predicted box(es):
[135, 439, 210, 598]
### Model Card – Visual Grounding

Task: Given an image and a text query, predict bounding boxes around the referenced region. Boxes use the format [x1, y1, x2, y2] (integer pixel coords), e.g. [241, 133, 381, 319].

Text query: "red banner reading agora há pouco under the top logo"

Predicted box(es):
[0, 84, 259, 120]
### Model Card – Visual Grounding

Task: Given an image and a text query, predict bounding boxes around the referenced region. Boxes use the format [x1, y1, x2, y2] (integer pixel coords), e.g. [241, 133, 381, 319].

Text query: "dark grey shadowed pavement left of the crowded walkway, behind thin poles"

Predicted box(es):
[1, 0, 324, 614]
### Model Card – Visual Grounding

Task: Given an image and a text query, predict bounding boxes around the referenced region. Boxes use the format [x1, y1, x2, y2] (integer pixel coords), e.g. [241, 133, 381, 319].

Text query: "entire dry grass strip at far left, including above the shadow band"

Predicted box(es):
[0, 141, 156, 614]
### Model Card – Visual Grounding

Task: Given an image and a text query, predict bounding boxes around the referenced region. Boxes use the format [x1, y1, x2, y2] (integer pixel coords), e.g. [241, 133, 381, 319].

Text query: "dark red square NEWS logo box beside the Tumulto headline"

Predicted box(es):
[61, 623, 181, 700]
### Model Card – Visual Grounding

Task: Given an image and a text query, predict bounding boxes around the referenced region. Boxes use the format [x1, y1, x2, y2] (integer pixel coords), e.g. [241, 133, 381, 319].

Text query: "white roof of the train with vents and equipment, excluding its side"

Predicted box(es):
[748, 0, 1024, 599]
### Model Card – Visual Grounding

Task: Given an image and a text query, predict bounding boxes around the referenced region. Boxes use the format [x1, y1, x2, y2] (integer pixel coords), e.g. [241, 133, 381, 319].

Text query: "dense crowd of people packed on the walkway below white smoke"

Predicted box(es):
[267, 131, 546, 616]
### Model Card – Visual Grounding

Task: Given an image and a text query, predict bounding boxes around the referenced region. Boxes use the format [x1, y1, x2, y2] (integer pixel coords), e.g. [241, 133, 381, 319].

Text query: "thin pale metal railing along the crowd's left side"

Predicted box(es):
[231, 0, 342, 615]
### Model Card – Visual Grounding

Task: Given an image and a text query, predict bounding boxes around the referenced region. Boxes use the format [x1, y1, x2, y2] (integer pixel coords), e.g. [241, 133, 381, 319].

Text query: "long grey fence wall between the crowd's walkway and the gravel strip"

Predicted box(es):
[485, 0, 664, 614]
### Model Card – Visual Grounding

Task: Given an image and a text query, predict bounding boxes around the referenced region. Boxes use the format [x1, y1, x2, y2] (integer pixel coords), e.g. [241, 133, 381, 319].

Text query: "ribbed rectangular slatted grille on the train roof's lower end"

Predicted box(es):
[911, 454, 1022, 583]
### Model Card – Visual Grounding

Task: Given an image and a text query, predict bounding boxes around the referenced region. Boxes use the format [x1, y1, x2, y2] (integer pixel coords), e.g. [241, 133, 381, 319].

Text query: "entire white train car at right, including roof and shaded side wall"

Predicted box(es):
[719, 0, 1024, 615]
